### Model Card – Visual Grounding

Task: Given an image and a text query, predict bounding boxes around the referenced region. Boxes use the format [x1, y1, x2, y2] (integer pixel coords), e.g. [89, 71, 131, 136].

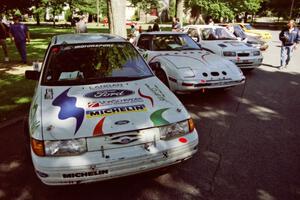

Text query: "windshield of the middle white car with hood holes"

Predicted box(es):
[152, 34, 200, 51]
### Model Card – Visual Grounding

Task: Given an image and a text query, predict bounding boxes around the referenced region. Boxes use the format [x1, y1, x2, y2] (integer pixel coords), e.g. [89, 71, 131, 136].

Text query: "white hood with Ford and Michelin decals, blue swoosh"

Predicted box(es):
[40, 77, 189, 140]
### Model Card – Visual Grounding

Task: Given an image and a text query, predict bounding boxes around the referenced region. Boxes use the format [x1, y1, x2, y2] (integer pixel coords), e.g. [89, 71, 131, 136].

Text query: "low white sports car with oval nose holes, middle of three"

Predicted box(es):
[135, 32, 245, 92]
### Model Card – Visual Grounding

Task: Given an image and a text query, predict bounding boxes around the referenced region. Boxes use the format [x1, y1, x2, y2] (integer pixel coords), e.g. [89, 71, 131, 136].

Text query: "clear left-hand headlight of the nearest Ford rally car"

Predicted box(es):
[45, 138, 87, 156]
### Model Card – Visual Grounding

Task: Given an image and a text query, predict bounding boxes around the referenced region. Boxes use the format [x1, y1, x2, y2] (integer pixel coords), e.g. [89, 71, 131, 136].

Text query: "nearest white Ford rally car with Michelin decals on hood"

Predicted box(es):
[24, 34, 198, 185]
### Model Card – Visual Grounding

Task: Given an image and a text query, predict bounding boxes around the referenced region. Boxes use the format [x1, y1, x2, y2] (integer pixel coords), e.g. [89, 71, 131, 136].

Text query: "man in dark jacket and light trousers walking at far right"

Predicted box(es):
[279, 20, 300, 69]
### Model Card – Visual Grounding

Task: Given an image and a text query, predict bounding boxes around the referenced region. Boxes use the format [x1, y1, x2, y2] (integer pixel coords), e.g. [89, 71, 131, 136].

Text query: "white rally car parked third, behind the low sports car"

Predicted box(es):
[184, 25, 263, 69]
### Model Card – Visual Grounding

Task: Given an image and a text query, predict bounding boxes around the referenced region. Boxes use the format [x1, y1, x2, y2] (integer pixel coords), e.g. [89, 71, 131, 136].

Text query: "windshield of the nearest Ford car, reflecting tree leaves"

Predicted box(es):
[43, 43, 153, 85]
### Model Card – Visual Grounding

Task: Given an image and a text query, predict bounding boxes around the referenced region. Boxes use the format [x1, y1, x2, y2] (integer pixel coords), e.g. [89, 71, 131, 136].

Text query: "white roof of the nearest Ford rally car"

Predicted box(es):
[51, 33, 127, 45]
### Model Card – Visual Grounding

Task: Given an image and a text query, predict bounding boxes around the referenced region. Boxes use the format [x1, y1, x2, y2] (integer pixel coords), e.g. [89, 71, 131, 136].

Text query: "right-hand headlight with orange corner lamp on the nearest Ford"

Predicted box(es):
[159, 119, 195, 140]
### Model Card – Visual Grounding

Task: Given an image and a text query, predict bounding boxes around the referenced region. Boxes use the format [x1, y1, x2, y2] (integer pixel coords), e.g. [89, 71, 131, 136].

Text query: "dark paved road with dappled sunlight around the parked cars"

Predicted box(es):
[0, 31, 300, 200]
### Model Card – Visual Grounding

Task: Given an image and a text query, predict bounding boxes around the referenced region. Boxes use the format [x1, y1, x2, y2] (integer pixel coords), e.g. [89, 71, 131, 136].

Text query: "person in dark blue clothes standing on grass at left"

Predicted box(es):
[10, 16, 30, 64]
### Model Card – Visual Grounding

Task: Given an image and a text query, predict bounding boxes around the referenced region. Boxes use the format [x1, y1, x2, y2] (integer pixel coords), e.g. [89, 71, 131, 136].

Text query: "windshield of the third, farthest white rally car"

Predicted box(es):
[201, 27, 236, 40]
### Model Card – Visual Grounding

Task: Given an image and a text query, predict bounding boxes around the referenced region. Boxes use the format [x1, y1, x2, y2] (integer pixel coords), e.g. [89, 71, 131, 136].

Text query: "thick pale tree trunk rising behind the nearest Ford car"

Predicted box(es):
[109, 0, 127, 38]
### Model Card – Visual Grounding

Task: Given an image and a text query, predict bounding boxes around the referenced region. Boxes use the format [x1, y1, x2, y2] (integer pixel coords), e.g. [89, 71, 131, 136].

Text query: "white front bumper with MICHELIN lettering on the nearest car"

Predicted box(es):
[32, 130, 198, 185]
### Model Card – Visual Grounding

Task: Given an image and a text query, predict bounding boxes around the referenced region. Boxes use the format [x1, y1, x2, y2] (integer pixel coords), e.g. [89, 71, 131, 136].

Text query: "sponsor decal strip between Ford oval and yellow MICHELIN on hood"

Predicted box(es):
[88, 97, 144, 108]
